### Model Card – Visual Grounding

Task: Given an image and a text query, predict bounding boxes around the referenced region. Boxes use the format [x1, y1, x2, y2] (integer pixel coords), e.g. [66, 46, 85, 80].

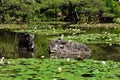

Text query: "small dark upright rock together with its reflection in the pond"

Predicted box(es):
[18, 33, 35, 58]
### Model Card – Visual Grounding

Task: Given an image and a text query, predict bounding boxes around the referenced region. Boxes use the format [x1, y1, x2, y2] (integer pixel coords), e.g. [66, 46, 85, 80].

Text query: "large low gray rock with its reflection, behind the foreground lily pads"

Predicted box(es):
[50, 39, 91, 59]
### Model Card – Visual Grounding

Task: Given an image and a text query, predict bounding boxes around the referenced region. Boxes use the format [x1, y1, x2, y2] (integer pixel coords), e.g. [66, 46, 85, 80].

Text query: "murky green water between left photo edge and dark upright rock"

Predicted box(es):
[0, 30, 18, 58]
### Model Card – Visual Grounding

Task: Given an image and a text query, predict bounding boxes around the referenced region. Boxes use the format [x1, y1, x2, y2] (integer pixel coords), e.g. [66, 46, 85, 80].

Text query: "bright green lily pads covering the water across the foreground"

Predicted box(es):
[0, 58, 120, 80]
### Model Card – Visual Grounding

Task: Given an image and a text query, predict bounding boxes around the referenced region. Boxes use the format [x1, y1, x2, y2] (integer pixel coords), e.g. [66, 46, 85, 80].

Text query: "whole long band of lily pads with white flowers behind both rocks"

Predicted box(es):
[15, 25, 120, 44]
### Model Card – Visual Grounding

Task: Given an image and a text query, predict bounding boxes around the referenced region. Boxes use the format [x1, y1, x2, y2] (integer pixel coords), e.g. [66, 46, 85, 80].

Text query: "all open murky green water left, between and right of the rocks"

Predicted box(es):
[0, 30, 120, 61]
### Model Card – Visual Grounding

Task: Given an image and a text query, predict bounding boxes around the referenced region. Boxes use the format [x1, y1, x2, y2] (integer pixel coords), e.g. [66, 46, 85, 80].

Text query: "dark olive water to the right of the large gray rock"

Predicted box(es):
[87, 44, 120, 61]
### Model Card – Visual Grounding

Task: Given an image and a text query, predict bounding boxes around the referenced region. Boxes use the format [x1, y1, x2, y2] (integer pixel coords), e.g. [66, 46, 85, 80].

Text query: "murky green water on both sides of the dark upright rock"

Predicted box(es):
[0, 30, 49, 58]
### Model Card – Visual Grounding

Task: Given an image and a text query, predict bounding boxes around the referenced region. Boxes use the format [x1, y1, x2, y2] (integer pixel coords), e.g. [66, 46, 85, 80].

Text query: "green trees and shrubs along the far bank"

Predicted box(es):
[0, 0, 120, 23]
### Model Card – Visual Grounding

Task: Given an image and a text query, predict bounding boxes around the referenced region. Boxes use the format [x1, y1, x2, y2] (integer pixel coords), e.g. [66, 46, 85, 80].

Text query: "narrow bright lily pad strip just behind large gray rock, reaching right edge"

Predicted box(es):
[62, 33, 120, 44]
